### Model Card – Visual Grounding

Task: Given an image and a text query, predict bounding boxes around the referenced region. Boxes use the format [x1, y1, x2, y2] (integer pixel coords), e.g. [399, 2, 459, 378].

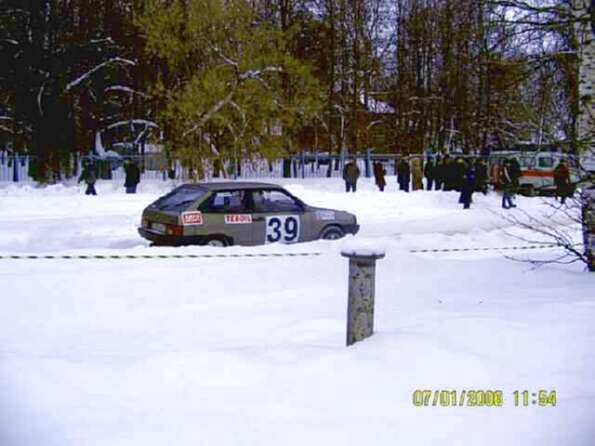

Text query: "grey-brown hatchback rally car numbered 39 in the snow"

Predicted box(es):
[138, 182, 359, 246]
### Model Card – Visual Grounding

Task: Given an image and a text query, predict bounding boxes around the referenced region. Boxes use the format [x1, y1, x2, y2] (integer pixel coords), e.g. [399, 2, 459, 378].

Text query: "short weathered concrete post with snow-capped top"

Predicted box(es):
[341, 249, 384, 346]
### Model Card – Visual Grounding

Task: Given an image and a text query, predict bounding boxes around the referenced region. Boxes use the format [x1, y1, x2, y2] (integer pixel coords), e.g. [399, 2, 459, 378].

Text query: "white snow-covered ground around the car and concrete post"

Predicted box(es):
[0, 177, 595, 446]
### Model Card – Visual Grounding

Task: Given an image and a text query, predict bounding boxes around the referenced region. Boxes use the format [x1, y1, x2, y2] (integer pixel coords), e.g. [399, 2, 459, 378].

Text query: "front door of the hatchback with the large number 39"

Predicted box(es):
[252, 189, 304, 244]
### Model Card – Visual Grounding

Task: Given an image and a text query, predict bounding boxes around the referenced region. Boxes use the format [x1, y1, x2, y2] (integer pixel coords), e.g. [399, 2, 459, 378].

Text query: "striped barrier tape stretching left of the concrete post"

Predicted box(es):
[0, 252, 322, 260]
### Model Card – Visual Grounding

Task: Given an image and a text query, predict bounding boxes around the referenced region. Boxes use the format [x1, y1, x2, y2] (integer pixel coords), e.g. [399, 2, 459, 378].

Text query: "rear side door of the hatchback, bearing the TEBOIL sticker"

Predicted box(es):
[200, 189, 253, 245]
